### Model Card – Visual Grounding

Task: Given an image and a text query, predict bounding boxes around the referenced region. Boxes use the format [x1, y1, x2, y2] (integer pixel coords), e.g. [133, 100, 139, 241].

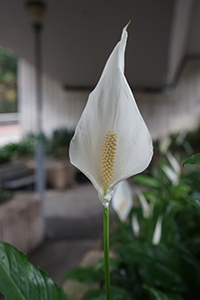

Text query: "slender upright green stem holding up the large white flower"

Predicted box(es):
[103, 205, 111, 300]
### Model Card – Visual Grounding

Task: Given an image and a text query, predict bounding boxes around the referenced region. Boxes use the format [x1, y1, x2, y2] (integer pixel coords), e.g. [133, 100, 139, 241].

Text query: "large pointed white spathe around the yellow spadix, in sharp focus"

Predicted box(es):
[69, 27, 153, 206]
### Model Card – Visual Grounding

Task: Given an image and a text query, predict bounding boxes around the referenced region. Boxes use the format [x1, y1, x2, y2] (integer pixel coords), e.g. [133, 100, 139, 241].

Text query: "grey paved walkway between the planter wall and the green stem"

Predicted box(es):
[29, 183, 115, 285]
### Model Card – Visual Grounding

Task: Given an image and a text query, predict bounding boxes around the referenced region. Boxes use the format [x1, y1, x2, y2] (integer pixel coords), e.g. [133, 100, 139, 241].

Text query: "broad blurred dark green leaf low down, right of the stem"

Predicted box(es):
[118, 241, 188, 292]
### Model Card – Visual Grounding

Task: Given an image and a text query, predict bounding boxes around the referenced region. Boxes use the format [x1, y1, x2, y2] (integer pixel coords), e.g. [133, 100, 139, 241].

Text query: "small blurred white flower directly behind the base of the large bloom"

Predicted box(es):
[112, 180, 133, 221]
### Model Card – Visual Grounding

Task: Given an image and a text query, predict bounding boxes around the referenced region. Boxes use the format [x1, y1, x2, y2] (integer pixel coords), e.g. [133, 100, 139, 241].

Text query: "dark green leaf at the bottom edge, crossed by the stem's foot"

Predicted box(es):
[83, 286, 134, 300]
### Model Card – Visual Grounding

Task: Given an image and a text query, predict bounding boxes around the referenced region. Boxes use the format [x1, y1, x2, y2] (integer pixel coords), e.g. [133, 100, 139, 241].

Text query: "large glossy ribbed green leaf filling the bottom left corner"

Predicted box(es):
[0, 242, 68, 300]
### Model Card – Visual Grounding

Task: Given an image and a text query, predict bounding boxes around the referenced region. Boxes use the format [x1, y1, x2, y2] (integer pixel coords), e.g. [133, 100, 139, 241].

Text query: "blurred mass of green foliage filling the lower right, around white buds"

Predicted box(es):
[63, 153, 200, 300]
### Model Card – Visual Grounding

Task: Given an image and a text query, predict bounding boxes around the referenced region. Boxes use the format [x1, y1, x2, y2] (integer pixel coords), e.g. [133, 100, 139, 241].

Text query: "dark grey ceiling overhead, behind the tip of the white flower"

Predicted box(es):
[0, 0, 200, 90]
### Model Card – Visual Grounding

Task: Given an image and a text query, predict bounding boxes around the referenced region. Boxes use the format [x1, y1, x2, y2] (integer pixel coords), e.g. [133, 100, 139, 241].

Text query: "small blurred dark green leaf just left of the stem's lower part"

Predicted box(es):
[64, 268, 104, 283]
